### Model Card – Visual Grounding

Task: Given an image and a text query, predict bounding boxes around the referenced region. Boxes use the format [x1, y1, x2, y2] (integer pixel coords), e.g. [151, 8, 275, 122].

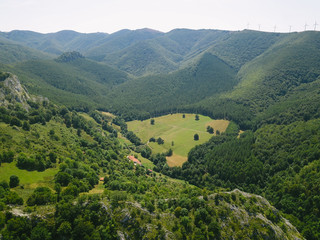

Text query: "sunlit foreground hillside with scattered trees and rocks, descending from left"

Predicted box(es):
[0, 72, 303, 240]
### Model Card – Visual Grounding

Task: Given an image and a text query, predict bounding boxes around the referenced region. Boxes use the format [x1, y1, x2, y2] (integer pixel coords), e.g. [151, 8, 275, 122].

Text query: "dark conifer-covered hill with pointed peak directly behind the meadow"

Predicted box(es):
[110, 54, 236, 119]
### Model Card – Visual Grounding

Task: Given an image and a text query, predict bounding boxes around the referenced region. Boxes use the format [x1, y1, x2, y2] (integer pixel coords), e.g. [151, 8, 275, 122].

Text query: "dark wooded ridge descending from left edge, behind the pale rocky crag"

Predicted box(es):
[2, 53, 128, 109]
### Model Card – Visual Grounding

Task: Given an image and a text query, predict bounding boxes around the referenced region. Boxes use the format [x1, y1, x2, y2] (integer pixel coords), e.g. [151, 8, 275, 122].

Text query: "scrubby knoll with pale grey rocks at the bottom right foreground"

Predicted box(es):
[208, 189, 304, 240]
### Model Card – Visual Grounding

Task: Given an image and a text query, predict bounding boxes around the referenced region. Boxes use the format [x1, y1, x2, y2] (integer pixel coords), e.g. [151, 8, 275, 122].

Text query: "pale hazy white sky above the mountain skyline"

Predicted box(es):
[0, 0, 320, 33]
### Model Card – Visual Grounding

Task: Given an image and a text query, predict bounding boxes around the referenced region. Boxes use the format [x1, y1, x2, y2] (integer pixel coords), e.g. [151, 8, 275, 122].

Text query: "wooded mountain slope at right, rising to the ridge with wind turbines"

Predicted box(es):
[231, 32, 320, 111]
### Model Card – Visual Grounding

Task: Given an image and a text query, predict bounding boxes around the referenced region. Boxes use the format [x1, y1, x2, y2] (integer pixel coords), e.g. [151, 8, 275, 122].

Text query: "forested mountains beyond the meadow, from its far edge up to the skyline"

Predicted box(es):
[0, 29, 319, 129]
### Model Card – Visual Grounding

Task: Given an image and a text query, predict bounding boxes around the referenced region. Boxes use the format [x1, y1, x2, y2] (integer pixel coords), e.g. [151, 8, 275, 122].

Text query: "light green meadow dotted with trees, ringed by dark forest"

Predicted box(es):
[127, 114, 229, 166]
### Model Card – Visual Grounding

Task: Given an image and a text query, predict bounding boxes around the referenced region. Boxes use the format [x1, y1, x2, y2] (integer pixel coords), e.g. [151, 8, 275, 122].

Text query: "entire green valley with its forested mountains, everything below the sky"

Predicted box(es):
[0, 29, 320, 240]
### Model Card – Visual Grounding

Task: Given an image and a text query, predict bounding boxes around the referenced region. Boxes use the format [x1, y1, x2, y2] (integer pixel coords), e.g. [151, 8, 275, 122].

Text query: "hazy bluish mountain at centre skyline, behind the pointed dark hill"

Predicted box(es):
[101, 29, 230, 76]
